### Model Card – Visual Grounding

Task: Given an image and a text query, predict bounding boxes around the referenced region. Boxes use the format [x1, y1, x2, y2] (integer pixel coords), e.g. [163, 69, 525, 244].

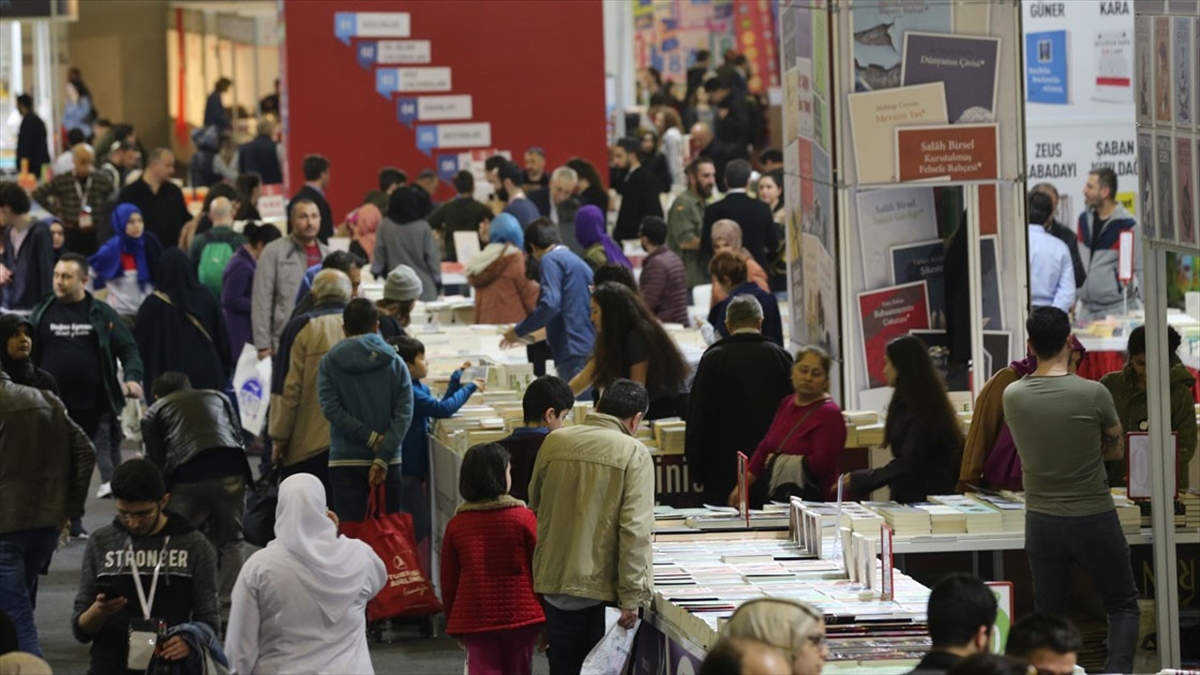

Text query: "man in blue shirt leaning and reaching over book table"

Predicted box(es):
[500, 217, 595, 382]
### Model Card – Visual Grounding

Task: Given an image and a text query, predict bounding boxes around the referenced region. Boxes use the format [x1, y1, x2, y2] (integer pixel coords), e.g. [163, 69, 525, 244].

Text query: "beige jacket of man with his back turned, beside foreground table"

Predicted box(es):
[529, 413, 654, 609]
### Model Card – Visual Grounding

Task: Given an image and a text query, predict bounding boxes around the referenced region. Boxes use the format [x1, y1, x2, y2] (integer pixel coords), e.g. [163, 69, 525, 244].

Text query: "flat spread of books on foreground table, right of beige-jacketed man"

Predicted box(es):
[654, 539, 929, 667]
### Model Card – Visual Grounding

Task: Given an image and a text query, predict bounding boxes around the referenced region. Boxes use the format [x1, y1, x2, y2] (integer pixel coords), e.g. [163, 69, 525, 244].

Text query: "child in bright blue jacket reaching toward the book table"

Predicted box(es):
[388, 335, 484, 574]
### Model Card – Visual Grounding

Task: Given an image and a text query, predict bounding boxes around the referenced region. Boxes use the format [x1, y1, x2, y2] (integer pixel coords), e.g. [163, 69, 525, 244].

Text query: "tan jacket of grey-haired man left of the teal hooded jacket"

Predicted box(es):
[269, 309, 346, 466]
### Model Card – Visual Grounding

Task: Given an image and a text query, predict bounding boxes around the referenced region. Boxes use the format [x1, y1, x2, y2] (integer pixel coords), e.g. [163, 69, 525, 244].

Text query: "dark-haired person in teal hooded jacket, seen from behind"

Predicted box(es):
[317, 298, 413, 522]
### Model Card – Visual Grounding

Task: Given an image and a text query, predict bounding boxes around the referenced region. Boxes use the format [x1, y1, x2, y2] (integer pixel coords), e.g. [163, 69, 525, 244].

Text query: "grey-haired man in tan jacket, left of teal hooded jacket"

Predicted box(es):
[268, 269, 353, 503]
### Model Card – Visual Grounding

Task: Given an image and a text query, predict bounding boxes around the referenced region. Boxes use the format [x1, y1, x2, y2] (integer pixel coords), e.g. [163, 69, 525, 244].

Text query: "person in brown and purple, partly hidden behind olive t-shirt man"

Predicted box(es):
[958, 335, 1087, 492]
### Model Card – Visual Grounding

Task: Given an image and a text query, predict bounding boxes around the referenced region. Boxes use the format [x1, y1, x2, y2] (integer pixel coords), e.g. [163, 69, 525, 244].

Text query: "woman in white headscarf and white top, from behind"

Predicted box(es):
[226, 473, 388, 674]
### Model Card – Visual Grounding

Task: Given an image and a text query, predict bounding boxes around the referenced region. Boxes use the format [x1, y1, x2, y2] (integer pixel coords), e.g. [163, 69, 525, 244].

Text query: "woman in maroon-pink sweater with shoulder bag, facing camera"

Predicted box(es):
[730, 345, 846, 506]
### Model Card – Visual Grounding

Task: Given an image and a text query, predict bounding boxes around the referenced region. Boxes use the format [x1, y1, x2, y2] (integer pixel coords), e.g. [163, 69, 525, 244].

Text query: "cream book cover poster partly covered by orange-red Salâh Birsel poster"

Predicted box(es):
[846, 82, 948, 184]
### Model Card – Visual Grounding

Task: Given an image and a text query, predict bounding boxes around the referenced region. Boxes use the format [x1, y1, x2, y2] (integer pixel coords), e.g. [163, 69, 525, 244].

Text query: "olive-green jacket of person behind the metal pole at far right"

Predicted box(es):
[1100, 354, 1196, 490]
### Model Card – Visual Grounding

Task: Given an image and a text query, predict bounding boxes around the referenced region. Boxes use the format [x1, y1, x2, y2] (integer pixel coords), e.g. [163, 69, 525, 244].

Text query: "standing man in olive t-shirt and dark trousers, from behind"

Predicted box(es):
[1004, 307, 1139, 673]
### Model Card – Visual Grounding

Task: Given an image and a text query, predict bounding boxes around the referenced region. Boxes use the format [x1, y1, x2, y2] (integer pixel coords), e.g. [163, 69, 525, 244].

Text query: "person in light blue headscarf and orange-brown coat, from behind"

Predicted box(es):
[463, 214, 539, 324]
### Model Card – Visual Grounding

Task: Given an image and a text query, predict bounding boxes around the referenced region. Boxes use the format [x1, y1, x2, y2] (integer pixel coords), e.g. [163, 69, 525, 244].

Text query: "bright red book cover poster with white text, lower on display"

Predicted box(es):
[858, 281, 929, 387]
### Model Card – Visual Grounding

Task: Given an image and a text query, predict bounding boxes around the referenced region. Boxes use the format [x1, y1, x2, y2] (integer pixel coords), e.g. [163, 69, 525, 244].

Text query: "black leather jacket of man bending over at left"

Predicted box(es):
[142, 389, 242, 483]
